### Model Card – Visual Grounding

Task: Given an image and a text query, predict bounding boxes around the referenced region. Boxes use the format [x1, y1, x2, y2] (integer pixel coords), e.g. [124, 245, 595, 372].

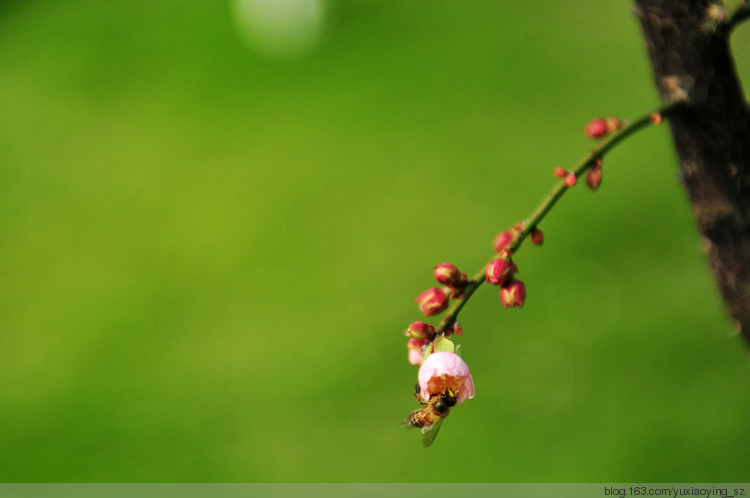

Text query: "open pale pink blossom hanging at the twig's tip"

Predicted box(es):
[417, 352, 474, 403]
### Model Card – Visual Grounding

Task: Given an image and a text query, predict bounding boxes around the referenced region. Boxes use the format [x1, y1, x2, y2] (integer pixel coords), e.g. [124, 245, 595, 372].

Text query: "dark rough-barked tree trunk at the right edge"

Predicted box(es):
[635, 0, 750, 342]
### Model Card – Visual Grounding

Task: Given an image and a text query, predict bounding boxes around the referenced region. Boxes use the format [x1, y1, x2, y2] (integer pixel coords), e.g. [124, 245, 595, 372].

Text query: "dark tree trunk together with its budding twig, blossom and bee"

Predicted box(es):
[404, 0, 750, 446]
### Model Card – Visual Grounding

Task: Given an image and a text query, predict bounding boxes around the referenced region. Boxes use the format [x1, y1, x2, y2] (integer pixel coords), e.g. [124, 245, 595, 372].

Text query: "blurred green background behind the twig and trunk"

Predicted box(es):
[0, 0, 750, 482]
